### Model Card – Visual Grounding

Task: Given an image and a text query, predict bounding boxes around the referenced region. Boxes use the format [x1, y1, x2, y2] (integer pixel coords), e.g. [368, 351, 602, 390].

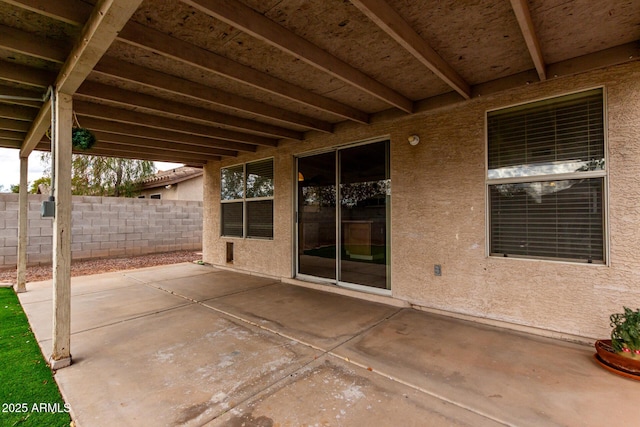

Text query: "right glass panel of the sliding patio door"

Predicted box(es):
[339, 141, 390, 289]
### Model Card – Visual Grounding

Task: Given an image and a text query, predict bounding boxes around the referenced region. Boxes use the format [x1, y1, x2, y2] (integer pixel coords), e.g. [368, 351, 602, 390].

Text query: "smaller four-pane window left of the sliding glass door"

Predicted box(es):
[220, 159, 274, 239]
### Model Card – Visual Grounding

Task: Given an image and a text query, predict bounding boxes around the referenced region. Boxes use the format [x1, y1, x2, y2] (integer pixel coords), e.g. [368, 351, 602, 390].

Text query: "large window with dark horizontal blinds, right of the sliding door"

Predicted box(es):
[487, 89, 606, 263]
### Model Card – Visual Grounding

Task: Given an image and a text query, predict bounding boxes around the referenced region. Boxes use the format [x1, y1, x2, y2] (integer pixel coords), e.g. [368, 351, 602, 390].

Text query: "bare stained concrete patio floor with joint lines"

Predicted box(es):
[20, 264, 640, 427]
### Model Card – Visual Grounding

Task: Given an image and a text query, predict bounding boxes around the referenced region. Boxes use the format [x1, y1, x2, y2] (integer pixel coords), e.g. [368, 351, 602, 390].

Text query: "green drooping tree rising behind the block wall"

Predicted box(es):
[41, 153, 156, 197]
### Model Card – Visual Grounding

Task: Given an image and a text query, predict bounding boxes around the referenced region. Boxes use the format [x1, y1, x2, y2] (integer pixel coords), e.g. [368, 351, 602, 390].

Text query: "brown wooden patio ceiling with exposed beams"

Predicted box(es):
[0, 0, 640, 166]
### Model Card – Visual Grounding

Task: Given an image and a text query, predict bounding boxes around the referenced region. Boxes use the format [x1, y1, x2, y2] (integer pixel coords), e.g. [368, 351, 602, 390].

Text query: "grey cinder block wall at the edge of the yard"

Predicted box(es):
[0, 194, 202, 268]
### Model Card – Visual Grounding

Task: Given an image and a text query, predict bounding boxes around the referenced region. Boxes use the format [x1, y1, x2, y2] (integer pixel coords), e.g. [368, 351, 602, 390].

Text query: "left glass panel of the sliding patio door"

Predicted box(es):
[298, 152, 336, 280]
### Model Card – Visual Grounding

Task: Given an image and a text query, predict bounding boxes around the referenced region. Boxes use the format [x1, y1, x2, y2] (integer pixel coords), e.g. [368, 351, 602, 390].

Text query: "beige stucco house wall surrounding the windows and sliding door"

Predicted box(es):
[203, 61, 640, 338]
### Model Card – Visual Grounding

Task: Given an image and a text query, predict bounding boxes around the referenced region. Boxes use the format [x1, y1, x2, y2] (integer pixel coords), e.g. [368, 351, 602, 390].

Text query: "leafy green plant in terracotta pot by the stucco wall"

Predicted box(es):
[595, 307, 640, 380]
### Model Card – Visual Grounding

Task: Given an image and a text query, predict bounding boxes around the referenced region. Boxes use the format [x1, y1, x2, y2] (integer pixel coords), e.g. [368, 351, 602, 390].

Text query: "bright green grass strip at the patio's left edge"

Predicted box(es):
[0, 288, 71, 427]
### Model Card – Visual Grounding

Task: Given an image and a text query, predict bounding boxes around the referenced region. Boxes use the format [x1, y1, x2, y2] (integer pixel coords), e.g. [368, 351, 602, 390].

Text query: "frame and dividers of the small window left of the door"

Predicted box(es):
[219, 157, 275, 240]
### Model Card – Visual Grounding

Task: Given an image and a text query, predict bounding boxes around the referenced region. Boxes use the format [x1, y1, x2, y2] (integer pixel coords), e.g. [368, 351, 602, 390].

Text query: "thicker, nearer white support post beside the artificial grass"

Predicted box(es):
[50, 89, 73, 369]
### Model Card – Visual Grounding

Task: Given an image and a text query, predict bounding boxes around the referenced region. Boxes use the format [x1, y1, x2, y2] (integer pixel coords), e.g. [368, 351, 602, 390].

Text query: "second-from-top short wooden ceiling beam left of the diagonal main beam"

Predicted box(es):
[0, 25, 69, 64]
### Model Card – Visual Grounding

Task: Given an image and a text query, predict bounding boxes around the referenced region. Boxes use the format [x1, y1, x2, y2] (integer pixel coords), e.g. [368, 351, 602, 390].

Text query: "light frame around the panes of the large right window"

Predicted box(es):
[484, 86, 610, 266]
